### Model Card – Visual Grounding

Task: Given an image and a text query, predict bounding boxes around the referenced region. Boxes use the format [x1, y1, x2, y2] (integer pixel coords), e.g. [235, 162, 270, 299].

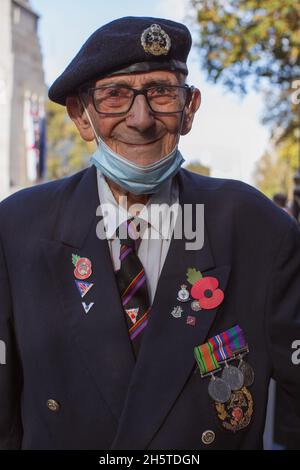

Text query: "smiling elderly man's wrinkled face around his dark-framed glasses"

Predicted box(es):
[80, 71, 200, 165]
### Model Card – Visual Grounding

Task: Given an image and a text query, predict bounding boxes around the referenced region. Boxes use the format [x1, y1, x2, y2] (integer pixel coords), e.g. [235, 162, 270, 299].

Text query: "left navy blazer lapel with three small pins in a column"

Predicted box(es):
[41, 167, 135, 422]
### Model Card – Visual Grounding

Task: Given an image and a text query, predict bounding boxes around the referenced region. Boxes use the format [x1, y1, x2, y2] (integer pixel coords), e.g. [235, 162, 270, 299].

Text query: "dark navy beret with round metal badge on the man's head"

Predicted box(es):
[49, 16, 192, 105]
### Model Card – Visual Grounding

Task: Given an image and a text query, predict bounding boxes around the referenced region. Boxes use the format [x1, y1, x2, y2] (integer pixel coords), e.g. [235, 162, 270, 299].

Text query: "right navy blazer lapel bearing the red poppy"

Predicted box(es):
[112, 171, 230, 449]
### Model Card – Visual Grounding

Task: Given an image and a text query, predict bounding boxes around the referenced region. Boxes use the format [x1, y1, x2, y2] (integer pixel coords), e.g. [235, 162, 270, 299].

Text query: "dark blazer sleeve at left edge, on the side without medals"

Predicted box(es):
[0, 234, 22, 450]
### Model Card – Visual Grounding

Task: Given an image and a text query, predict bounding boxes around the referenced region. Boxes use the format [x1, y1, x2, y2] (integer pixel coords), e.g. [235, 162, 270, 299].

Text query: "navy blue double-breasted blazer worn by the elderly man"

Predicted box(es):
[0, 167, 300, 450]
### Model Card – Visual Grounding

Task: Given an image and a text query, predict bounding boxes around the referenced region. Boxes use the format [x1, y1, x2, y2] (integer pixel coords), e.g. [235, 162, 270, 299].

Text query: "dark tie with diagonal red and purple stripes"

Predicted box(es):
[115, 219, 150, 356]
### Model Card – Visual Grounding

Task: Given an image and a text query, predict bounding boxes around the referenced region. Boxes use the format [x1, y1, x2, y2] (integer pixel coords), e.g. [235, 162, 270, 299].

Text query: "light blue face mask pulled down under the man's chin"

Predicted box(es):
[92, 137, 184, 194]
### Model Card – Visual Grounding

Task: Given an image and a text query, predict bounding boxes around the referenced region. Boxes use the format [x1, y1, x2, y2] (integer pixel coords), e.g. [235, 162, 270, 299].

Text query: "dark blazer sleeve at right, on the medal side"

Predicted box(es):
[265, 220, 300, 428]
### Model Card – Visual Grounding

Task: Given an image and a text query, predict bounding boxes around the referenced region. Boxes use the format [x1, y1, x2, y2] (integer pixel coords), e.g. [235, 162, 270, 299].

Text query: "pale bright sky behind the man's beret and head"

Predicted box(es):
[30, 0, 269, 185]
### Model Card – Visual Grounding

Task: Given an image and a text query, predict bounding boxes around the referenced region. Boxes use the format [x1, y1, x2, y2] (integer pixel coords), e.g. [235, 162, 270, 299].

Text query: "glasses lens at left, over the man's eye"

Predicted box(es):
[94, 86, 133, 114]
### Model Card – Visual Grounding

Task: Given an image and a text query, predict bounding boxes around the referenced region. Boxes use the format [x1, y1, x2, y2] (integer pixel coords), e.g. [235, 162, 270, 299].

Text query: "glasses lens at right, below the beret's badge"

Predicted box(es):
[147, 85, 187, 113]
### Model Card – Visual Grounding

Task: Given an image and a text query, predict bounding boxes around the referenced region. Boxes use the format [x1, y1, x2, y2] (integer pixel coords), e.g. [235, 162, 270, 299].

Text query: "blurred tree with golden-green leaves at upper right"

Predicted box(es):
[191, 0, 300, 193]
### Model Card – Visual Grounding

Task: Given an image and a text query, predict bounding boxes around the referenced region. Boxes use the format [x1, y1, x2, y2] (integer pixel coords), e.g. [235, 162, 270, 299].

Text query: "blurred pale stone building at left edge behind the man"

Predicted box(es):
[0, 0, 46, 200]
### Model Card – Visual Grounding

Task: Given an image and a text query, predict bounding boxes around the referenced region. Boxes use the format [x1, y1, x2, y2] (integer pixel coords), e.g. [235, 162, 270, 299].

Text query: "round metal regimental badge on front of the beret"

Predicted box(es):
[141, 24, 171, 56]
